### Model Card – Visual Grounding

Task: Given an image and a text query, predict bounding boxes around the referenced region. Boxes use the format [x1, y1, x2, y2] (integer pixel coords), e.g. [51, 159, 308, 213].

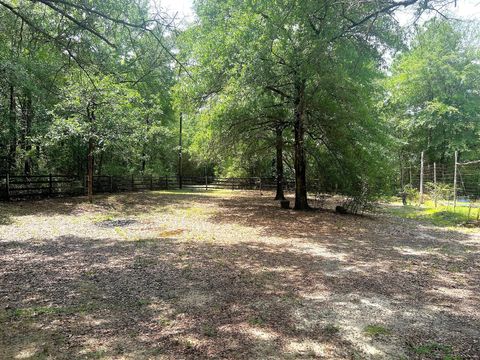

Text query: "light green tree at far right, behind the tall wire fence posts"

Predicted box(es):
[386, 18, 480, 164]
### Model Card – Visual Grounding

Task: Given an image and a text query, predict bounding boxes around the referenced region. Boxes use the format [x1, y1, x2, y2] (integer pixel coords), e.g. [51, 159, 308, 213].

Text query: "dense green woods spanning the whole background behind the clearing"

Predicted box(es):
[0, 0, 480, 209]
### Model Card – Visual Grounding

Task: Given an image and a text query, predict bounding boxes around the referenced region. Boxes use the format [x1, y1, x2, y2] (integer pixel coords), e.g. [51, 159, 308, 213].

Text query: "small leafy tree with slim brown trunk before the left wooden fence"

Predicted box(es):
[49, 74, 142, 202]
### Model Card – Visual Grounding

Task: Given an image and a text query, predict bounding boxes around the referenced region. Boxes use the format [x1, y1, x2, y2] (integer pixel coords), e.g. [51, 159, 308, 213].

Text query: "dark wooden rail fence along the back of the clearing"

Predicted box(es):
[0, 174, 295, 201]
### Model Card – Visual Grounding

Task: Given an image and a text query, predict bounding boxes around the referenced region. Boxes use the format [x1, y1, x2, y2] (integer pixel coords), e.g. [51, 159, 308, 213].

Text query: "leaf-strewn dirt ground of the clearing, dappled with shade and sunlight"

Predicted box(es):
[0, 191, 480, 359]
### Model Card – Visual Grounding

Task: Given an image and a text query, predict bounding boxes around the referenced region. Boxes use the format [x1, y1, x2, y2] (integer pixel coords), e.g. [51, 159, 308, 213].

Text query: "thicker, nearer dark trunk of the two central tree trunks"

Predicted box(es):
[294, 80, 310, 210]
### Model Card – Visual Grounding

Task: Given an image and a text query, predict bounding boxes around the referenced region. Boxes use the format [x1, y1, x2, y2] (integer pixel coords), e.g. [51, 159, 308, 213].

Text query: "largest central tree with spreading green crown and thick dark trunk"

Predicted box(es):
[178, 0, 452, 210]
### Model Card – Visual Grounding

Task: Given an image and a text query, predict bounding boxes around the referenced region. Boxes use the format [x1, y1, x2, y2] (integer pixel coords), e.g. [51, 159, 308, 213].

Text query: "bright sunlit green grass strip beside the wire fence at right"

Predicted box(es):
[387, 201, 478, 227]
